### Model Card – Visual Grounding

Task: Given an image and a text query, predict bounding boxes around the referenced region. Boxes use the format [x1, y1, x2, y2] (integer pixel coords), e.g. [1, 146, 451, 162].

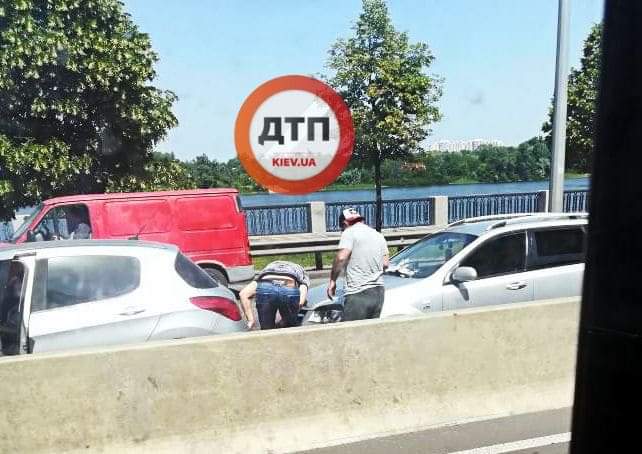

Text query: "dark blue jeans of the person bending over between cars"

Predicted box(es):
[256, 282, 301, 329]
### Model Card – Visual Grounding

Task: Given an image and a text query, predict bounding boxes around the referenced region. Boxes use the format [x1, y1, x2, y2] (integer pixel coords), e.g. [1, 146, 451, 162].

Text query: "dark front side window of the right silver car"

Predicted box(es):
[460, 232, 526, 279]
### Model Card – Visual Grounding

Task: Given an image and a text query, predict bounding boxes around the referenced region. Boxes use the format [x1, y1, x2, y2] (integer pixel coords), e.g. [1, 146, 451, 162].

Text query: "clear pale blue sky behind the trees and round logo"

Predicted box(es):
[123, 0, 603, 161]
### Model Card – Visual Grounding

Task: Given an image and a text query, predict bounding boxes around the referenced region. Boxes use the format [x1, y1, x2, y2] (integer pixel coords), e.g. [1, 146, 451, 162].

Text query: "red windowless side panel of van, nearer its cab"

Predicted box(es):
[105, 199, 172, 236]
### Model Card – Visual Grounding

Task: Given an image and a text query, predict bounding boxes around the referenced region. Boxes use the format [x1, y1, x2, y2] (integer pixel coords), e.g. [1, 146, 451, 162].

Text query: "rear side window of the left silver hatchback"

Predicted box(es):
[32, 255, 140, 312]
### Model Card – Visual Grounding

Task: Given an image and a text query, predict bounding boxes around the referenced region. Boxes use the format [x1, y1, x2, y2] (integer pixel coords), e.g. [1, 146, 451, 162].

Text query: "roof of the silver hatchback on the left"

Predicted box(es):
[0, 240, 178, 260]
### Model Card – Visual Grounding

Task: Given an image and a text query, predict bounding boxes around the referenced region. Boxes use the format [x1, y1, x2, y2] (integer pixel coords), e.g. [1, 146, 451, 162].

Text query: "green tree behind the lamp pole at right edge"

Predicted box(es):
[542, 24, 602, 172]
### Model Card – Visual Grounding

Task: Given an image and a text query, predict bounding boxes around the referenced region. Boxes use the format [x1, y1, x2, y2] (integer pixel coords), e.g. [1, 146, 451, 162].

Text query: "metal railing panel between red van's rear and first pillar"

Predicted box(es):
[243, 204, 312, 235]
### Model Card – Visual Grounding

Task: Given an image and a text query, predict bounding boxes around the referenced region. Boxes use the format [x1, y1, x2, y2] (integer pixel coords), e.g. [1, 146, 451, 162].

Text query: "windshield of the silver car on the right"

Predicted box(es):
[387, 232, 477, 279]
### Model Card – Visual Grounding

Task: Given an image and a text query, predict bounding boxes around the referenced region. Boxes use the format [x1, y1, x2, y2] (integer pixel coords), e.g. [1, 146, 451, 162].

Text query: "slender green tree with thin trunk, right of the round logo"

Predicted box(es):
[328, 0, 442, 230]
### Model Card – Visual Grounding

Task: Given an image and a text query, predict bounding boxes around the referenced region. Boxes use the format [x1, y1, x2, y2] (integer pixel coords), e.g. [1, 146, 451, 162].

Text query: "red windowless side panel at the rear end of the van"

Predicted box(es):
[176, 196, 236, 232]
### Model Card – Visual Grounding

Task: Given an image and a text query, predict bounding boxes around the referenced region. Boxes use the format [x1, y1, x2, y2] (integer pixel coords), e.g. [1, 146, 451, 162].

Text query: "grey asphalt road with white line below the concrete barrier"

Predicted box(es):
[301, 408, 571, 454]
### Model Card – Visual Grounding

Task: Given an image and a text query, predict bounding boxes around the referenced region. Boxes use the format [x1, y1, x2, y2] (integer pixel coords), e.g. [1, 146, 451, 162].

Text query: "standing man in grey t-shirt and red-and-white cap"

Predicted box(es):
[328, 208, 389, 321]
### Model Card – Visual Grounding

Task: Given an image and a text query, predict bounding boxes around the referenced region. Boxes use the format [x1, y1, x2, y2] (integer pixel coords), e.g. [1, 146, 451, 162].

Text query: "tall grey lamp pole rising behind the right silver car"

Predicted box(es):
[549, 0, 570, 212]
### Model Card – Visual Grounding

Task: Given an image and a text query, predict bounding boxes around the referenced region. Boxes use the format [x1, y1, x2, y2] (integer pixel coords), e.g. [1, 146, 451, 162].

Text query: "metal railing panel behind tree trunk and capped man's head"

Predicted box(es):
[325, 198, 435, 232]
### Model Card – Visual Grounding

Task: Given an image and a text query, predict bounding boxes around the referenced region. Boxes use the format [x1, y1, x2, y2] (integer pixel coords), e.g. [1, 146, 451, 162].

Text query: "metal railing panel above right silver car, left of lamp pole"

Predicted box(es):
[448, 192, 538, 222]
